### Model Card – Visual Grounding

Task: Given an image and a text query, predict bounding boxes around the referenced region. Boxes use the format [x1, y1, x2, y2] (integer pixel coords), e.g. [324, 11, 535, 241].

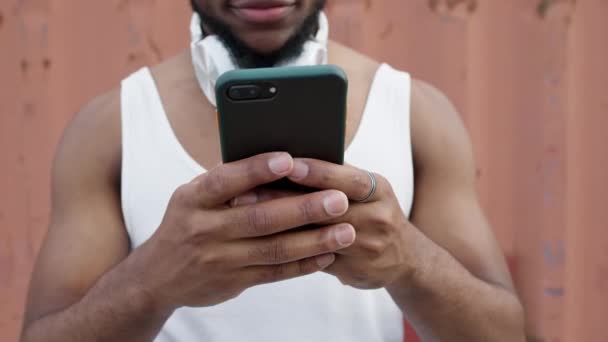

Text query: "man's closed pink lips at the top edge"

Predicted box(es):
[229, 0, 296, 25]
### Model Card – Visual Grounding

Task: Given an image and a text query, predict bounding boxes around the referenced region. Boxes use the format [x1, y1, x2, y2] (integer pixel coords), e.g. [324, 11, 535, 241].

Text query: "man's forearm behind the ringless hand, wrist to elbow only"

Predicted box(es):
[21, 259, 170, 342]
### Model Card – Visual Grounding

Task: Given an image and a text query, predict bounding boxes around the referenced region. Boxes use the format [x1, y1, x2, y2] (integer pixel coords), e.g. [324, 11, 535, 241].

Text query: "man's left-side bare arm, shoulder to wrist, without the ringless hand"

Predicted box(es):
[22, 91, 172, 341]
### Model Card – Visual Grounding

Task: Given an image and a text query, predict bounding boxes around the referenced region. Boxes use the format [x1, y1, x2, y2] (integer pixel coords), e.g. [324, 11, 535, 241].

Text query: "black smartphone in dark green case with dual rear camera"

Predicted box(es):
[216, 65, 348, 174]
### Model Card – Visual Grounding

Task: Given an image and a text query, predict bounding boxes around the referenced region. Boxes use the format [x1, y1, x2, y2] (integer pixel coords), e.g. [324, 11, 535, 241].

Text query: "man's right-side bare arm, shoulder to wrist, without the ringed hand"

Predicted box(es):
[389, 82, 524, 341]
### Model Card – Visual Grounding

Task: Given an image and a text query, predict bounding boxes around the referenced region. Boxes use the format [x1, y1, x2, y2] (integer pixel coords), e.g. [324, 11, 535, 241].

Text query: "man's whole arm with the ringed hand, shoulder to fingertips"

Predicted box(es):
[226, 76, 524, 342]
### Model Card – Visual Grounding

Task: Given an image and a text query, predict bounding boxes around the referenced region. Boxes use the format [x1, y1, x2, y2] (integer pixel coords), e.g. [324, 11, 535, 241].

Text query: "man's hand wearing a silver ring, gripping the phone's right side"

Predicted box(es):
[232, 159, 416, 289]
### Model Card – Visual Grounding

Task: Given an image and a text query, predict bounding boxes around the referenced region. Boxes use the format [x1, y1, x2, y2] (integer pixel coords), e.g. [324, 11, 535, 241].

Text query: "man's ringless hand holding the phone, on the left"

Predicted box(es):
[129, 153, 355, 311]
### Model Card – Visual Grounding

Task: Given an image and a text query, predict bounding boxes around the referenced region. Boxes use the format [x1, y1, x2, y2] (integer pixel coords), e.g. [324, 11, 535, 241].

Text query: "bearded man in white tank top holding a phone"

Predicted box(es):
[22, 0, 524, 342]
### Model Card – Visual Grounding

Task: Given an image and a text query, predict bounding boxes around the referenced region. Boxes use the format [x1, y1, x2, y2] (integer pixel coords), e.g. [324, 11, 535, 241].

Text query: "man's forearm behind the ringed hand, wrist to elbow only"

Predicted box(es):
[388, 232, 524, 342]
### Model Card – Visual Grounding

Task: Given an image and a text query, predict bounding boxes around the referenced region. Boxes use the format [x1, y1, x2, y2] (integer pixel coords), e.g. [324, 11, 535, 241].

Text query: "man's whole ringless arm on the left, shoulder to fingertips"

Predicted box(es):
[22, 87, 355, 342]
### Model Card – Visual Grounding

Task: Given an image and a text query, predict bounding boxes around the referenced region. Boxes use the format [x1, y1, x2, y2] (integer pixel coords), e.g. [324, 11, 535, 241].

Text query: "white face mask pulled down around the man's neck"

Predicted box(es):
[190, 13, 329, 106]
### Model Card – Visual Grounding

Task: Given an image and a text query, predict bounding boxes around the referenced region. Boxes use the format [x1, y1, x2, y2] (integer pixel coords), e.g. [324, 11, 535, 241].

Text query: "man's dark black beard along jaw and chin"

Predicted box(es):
[191, 0, 327, 68]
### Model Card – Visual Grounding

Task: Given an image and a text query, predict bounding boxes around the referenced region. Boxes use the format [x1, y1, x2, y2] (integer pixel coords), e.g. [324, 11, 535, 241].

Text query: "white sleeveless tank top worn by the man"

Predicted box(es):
[121, 64, 414, 342]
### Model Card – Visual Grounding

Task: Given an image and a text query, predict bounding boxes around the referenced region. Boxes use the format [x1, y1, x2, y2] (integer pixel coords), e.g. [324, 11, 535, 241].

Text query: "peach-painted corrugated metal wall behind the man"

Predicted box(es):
[0, 0, 608, 342]
